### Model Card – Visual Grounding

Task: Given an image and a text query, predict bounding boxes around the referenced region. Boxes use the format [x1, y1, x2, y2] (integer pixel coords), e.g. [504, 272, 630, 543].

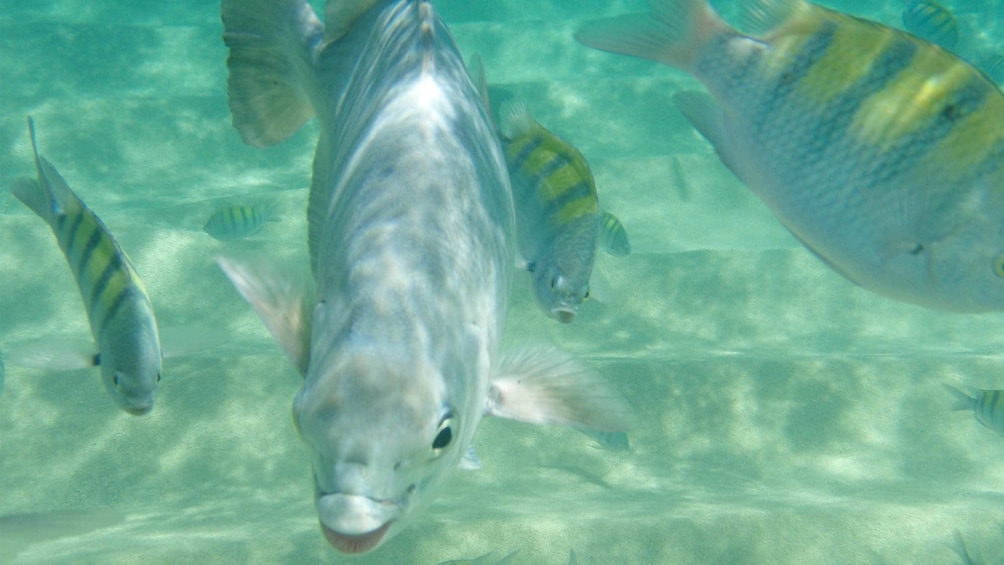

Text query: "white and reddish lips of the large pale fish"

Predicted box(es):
[315, 493, 401, 554]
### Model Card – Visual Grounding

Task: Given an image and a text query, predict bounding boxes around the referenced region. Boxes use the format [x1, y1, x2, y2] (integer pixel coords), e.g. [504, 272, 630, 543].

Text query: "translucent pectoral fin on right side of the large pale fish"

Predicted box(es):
[485, 346, 634, 432]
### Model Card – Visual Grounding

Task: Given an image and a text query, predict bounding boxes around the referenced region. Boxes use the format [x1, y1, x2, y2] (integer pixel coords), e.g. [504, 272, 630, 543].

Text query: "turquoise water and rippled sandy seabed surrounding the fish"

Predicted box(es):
[0, 0, 1004, 565]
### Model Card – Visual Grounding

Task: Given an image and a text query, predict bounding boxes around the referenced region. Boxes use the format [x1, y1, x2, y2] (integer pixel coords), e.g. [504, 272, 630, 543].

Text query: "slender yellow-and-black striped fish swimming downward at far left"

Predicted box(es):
[11, 117, 161, 415]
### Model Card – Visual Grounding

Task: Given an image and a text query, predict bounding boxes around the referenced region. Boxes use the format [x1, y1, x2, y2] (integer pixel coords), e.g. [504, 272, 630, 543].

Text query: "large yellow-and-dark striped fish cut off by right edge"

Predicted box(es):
[576, 0, 1004, 312]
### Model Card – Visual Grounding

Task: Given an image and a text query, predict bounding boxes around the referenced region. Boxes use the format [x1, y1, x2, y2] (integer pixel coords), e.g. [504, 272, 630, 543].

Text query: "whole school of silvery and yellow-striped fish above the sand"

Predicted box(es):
[0, 0, 1004, 563]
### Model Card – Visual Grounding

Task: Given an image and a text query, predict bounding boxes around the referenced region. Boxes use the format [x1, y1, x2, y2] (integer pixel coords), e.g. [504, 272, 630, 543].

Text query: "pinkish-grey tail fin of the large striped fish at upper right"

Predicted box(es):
[575, 0, 730, 69]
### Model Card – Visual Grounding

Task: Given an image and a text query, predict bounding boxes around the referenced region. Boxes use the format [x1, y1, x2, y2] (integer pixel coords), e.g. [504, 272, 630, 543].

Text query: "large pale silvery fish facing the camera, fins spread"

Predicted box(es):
[218, 0, 630, 554]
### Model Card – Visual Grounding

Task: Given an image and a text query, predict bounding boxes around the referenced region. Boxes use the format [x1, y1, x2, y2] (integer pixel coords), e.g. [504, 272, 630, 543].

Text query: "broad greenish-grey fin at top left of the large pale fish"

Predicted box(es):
[221, 0, 324, 148]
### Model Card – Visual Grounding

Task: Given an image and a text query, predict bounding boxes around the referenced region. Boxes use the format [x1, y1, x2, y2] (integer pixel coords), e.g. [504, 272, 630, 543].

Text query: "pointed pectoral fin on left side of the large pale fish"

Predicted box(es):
[216, 256, 314, 375]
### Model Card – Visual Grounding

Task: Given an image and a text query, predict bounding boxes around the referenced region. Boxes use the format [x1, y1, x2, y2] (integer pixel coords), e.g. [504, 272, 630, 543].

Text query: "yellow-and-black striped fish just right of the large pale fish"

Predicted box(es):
[499, 97, 630, 323]
